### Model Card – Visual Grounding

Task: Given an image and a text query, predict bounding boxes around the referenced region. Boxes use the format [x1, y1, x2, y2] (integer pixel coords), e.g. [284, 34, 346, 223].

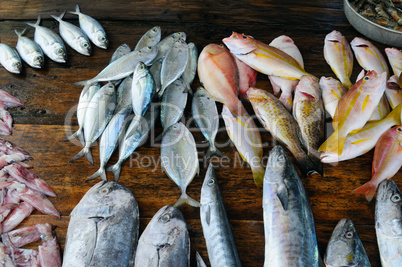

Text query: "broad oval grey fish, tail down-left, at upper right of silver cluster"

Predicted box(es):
[161, 40, 189, 94]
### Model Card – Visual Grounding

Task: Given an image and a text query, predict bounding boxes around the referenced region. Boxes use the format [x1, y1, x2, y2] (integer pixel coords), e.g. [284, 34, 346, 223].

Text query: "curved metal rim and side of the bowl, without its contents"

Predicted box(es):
[343, 0, 402, 47]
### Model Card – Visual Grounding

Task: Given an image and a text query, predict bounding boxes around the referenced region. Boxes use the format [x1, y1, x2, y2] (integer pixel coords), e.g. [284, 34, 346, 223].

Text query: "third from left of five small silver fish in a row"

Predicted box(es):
[27, 16, 67, 63]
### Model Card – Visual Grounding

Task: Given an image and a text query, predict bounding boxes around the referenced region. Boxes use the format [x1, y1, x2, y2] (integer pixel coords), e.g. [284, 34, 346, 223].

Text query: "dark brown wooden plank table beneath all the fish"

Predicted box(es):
[0, 0, 402, 266]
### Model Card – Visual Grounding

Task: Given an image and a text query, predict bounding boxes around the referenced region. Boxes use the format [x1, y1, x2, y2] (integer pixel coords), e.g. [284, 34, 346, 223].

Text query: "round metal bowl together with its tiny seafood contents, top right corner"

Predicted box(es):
[343, 0, 402, 47]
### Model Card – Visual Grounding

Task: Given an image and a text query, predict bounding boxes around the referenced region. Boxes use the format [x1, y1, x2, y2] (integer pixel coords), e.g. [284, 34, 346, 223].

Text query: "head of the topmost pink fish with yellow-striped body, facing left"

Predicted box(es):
[222, 32, 258, 55]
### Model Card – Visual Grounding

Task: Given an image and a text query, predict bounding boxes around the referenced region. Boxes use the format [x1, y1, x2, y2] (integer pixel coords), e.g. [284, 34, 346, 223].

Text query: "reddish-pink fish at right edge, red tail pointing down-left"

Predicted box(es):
[353, 126, 402, 201]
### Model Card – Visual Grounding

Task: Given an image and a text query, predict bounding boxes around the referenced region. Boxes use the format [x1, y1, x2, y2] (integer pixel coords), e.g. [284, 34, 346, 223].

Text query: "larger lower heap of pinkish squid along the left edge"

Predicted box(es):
[0, 139, 61, 267]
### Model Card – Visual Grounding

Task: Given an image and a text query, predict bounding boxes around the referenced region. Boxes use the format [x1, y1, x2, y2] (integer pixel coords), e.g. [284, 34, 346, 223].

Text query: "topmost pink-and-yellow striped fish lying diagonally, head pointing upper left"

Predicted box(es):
[222, 32, 309, 80]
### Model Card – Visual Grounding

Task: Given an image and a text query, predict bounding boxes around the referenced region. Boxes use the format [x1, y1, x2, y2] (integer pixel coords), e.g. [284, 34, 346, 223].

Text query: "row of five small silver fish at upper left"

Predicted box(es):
[0, 5, 109, 74]
